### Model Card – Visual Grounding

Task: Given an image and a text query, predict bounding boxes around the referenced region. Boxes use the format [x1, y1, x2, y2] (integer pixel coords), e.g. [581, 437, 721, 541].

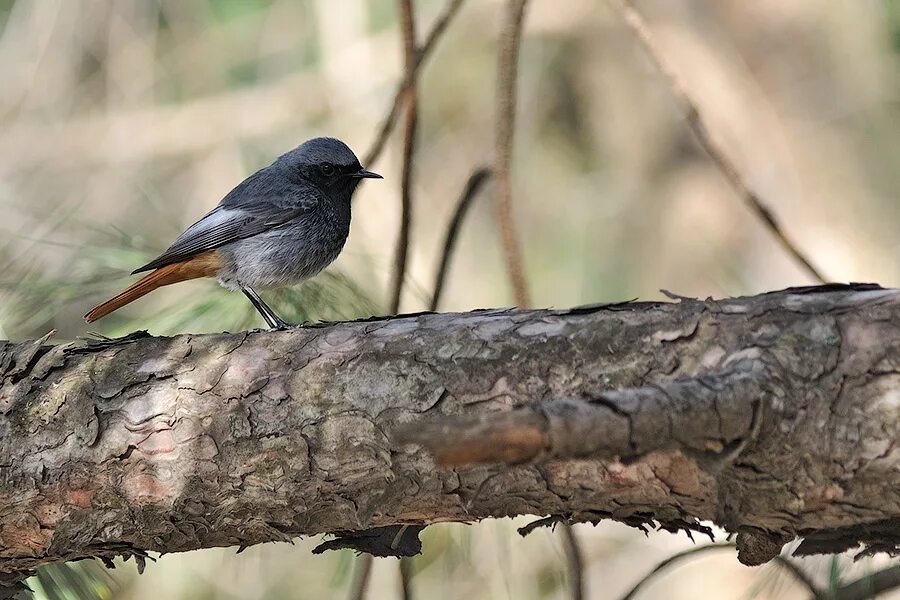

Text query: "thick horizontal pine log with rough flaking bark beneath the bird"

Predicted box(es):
[0, 286, 900, 580]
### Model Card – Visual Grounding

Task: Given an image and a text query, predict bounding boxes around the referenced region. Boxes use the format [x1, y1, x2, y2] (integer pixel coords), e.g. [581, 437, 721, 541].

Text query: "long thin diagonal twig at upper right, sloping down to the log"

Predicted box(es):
[610, 0, 825, 283]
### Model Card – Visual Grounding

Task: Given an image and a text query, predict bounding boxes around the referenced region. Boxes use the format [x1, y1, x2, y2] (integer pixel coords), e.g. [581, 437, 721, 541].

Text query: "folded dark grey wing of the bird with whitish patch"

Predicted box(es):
[132, 200, 311, 274]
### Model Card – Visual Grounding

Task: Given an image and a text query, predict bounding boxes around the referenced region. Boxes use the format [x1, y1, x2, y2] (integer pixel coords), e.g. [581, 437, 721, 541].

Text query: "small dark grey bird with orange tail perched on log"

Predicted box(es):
[84, 137, 382, 329]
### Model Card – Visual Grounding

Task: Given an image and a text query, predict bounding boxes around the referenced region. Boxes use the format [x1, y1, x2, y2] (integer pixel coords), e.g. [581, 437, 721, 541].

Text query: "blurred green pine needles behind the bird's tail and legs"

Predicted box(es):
[0, 232, 377, 337]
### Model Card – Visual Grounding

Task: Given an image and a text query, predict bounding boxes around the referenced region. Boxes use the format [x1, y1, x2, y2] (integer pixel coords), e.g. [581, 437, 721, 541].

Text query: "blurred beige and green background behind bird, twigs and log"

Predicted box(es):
[0, 0, 900, 599]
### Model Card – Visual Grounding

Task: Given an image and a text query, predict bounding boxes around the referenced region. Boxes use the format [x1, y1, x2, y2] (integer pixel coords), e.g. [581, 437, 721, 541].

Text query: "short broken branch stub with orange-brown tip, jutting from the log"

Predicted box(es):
[396, 350, 768, 467]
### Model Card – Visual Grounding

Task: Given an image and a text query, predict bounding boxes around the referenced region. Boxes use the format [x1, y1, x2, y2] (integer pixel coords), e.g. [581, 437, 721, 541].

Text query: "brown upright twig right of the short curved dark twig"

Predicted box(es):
[494, 0, 531, 308]
